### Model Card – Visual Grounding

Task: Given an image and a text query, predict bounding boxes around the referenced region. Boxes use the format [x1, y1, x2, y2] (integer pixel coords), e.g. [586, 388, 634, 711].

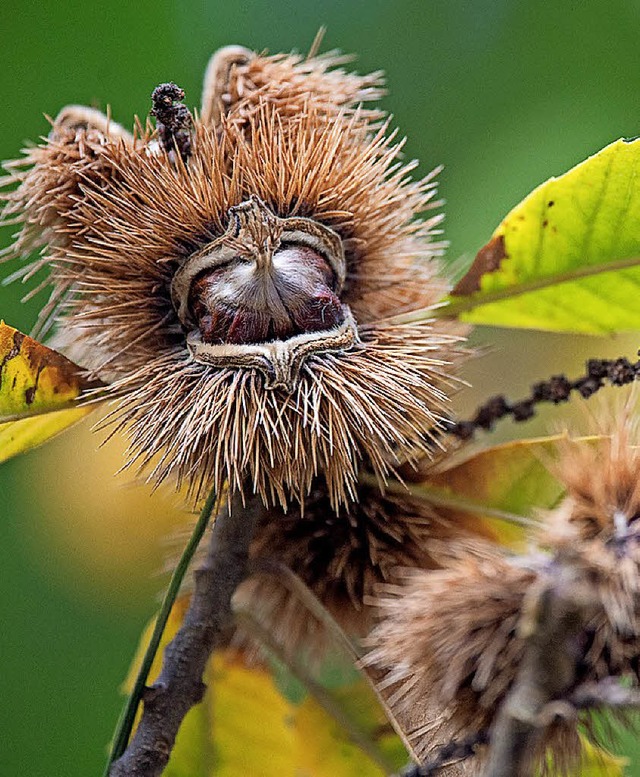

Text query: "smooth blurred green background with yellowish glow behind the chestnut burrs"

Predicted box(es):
[0, 0, 640, 777]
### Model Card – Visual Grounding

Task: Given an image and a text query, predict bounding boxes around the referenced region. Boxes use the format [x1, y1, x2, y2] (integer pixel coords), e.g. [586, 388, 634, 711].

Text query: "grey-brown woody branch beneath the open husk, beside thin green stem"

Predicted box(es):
[109, 496, 264, 777]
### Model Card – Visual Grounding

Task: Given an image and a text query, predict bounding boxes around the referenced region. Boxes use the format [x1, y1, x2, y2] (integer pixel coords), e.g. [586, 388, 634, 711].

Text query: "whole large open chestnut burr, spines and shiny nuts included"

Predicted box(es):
[3, 47, 464, 507]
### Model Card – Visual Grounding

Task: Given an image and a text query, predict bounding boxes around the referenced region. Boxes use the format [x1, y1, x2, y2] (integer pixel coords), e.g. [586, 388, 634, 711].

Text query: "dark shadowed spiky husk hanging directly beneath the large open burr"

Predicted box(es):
[236, 479, 496, 655]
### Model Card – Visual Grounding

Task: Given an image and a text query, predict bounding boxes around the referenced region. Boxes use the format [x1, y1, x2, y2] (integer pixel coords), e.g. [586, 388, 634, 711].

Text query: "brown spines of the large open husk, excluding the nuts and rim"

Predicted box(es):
[4, 45, 462, 505]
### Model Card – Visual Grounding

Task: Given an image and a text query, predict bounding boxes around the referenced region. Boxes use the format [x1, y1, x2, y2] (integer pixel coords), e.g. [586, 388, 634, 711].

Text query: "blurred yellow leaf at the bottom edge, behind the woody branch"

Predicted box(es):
[123, 596, 408, 777]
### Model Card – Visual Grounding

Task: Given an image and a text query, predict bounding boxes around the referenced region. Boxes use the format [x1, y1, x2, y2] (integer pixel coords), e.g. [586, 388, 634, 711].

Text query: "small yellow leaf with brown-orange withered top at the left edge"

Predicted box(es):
[0, 321, 95, 462]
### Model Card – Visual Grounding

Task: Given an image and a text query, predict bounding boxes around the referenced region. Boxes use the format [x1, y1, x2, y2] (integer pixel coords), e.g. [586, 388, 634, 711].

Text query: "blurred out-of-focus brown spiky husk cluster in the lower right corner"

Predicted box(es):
[367, 422, 640, 773]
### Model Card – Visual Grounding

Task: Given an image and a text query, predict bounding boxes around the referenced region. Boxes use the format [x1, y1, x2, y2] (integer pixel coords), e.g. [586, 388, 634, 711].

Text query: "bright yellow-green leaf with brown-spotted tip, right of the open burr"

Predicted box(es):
[442, 140, 640, 334]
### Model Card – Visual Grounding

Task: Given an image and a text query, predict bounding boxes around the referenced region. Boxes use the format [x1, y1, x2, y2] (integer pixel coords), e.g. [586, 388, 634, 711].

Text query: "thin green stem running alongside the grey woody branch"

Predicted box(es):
[103, 490, 218, 777]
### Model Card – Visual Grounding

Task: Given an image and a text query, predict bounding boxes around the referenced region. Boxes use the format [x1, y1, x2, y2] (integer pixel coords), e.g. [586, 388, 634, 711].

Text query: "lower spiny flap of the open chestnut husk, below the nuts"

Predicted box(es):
[97, 326, 462, 504]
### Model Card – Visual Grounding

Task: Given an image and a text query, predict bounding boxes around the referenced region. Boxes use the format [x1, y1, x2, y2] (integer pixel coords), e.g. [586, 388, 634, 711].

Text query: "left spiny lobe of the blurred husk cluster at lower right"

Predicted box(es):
[367, 551, 535, 760]
